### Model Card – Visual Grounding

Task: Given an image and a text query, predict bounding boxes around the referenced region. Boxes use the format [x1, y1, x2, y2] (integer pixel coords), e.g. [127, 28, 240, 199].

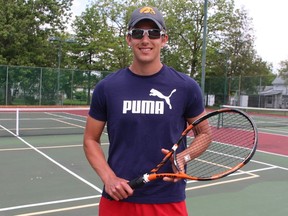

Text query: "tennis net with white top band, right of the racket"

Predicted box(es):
[222, 105, 288, 129]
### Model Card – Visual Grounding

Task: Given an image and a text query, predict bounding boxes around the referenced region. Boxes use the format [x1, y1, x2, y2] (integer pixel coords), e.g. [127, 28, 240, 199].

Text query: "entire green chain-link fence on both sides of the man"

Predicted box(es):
[0, 65, 288, 108]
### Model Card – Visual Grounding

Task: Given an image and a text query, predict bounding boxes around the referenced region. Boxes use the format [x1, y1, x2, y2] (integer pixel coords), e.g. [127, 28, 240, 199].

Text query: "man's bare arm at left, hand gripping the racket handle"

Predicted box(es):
[83, 116, 133, 200]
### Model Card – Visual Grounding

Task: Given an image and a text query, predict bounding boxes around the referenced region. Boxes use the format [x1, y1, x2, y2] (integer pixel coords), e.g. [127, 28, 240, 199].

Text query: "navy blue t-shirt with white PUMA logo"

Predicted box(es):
[89, 65, 204, 203]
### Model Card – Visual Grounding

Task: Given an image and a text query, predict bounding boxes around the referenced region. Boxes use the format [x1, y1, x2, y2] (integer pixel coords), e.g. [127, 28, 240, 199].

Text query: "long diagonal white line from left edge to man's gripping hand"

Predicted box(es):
[0, 125, 102, 193]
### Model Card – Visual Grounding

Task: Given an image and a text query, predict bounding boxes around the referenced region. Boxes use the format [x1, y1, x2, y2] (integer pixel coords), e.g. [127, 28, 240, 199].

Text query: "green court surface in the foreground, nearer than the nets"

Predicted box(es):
[0, 134, 288, 216]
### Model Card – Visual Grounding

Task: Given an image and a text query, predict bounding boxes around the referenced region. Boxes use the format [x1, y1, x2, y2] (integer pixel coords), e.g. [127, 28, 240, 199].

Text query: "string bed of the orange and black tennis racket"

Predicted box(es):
[186, 112, 255, 178]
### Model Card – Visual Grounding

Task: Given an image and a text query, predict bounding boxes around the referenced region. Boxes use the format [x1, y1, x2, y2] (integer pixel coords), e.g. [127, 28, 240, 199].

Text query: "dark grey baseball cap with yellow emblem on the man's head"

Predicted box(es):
[128, 7, 166, 30]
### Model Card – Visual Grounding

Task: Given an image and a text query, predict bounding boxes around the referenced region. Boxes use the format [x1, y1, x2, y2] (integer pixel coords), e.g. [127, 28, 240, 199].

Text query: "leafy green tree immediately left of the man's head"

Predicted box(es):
[73, 0, 131, 104]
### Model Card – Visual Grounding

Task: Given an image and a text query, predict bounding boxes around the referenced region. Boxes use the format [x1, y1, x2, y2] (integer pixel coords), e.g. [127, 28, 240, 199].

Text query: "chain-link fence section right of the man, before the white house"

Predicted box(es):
[205, 75, 288, 109]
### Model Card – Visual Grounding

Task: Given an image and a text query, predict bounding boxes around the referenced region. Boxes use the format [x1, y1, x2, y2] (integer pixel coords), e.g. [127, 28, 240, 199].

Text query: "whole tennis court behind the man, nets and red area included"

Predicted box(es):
[0, 108, 288, 216]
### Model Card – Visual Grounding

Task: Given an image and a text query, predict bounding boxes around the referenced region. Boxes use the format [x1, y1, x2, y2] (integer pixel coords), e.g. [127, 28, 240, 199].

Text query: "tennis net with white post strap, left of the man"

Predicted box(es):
[0, 107, 89, 137]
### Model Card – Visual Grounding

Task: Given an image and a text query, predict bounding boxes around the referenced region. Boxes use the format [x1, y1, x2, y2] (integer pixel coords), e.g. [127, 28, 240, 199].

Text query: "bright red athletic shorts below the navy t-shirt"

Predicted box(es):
[99, 197, 188, 216]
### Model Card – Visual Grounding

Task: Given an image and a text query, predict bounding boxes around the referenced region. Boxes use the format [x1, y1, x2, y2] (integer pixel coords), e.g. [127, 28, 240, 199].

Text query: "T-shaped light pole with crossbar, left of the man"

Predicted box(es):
[48, 36, 75, 105]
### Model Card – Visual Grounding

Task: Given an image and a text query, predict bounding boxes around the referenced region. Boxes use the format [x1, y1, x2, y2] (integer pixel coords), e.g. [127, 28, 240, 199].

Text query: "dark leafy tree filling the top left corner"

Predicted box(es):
[0, 0, 72, 104]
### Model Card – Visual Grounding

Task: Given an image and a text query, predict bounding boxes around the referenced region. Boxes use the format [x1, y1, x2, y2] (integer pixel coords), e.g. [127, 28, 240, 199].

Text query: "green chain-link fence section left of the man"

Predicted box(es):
[0, 65, 110, 105]
